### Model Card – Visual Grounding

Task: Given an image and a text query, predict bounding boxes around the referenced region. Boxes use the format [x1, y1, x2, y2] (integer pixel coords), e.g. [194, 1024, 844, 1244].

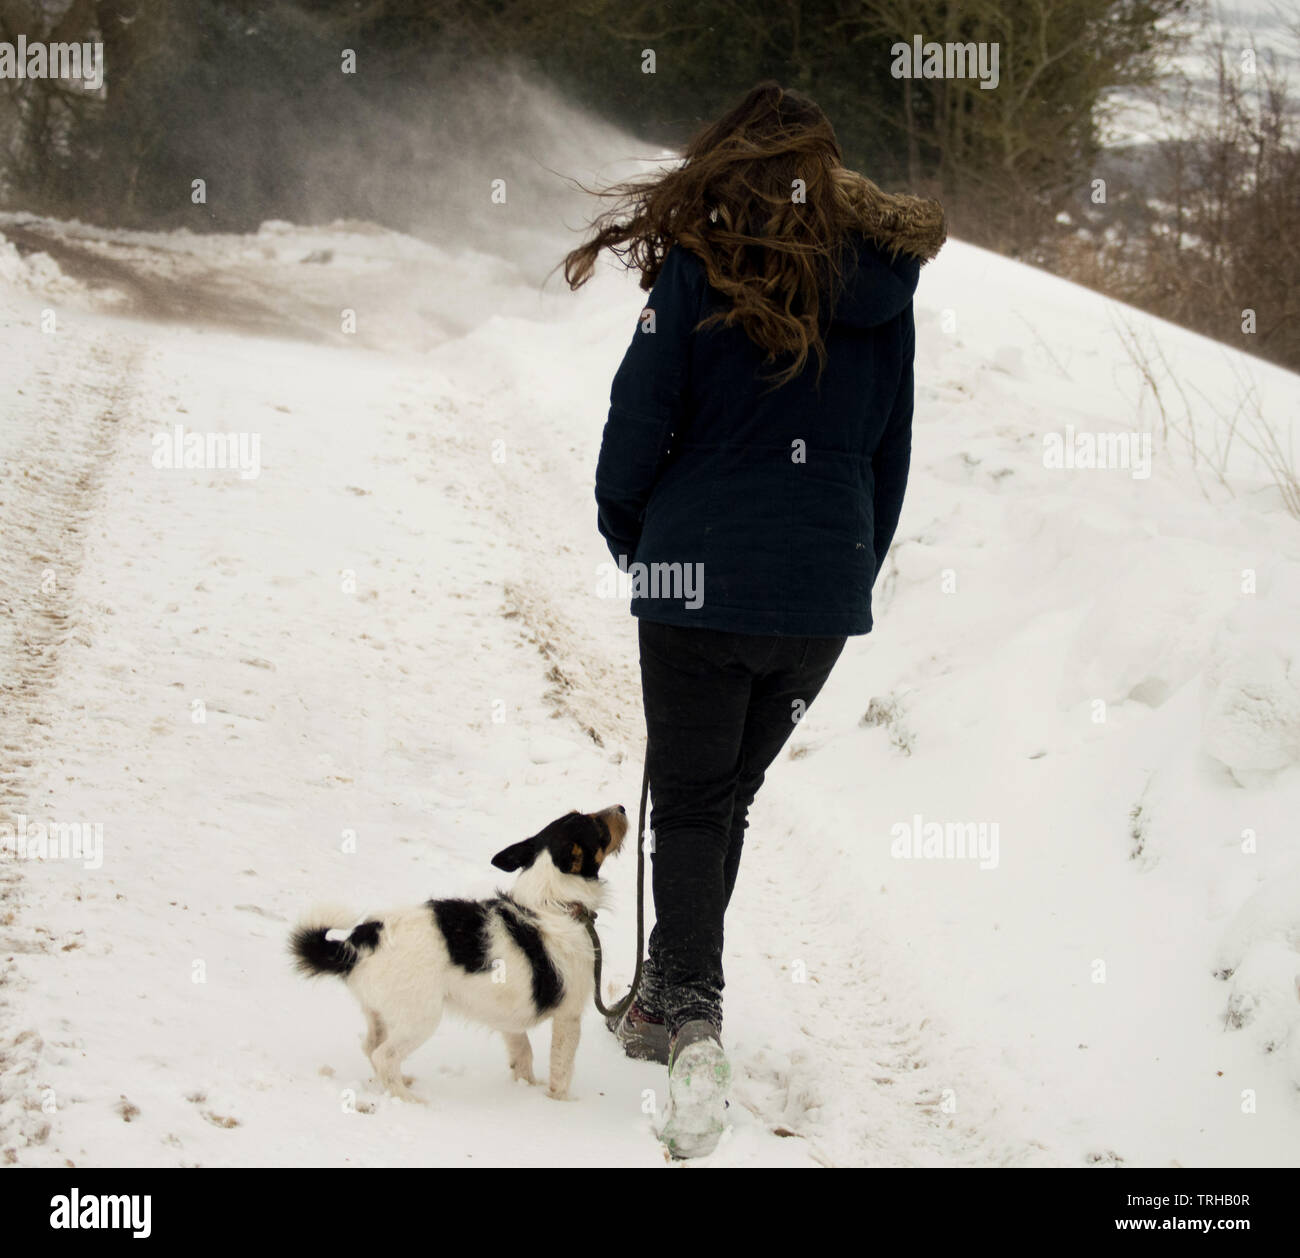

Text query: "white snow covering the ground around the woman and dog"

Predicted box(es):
[0, 159, 1300, 1168]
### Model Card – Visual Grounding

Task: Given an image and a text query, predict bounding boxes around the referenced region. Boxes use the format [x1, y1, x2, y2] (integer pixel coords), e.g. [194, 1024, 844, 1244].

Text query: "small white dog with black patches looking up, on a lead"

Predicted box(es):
[290, 804, 628, 1101]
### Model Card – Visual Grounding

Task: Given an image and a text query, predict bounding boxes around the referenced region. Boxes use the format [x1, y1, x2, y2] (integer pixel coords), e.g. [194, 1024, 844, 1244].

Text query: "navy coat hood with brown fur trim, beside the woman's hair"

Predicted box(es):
[835, 169, 948, 327]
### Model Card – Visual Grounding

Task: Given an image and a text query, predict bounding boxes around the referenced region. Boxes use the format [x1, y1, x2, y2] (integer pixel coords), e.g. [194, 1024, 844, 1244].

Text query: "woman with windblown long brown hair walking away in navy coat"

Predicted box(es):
[564, 82, 945, 1157]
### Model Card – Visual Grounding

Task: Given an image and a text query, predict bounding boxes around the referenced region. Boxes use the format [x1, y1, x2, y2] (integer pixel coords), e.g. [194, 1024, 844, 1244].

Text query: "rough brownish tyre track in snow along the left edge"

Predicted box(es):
[0, 320, 144, 1164]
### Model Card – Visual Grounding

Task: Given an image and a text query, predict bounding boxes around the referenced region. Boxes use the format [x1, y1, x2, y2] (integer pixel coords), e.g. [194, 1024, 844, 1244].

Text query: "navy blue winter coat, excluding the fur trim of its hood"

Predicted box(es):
[595, 237, 920, 637]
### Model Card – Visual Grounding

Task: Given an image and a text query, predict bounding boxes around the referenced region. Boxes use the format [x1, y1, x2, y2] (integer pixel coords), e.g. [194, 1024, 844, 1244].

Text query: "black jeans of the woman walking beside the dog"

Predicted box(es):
[638, 620, 846, 1032]
